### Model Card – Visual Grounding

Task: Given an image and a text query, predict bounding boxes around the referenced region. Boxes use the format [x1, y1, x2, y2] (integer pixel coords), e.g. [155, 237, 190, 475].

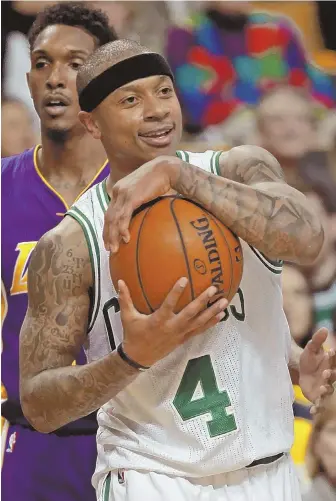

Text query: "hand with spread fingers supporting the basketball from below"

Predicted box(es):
[118, 278, 228, 367]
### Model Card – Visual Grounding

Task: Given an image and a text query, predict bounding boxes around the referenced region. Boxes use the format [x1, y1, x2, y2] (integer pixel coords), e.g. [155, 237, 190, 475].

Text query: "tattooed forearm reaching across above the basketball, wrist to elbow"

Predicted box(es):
[172, 159, 323, 264]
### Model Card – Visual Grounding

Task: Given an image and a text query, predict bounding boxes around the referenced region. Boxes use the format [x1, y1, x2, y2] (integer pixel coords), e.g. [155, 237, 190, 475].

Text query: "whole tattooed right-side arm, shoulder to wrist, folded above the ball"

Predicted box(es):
[173, 146, 324, 264]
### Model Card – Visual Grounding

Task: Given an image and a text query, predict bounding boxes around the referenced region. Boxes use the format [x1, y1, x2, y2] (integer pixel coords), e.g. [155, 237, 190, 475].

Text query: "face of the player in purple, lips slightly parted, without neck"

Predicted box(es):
[27, 25, 95, 138]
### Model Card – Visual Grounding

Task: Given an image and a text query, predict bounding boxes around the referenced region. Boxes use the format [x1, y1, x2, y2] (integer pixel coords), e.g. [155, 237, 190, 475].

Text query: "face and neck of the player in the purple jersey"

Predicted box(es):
[27, 25, 106, 206]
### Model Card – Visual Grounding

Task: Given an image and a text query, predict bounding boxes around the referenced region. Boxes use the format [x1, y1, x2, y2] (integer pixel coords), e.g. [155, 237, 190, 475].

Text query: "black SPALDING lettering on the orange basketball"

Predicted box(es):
[190, 216, 224, 306]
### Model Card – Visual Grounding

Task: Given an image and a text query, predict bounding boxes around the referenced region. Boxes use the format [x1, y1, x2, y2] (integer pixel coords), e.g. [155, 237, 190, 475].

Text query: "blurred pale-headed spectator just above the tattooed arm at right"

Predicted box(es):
[256, 86, 335, 190]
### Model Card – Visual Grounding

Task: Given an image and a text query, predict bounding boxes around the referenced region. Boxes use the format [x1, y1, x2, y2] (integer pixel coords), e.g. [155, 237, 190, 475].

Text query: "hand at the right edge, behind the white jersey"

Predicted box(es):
[299, 328, 336, 414]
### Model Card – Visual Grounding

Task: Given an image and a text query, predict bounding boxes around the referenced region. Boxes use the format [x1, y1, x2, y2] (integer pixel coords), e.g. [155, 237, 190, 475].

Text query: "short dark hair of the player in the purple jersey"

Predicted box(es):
[28, 2, 118, 50]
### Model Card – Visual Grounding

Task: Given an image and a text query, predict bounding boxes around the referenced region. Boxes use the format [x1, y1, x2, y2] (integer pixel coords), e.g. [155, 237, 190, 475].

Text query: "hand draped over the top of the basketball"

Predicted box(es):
[103, 157, 179, 253]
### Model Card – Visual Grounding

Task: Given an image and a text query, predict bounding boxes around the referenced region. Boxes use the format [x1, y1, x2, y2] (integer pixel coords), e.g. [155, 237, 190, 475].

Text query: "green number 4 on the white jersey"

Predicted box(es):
[173, 355, 237, 437]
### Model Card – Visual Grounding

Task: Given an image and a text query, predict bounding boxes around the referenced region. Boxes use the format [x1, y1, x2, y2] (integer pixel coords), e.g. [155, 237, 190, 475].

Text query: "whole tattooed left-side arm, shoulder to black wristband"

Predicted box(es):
[20, 218, 138, 432]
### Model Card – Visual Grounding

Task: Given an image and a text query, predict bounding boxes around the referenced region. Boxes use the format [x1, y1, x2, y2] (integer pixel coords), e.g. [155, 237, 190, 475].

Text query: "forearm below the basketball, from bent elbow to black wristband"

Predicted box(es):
[21, 352, 139, 433]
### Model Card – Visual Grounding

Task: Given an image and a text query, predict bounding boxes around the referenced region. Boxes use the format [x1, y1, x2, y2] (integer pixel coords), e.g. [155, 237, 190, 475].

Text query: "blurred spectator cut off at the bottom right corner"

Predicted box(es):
[303, 394, 336, 501]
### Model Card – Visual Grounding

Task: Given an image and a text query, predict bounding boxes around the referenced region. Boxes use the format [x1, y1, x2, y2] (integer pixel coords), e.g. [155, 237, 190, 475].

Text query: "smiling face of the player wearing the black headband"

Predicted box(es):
[92, 76, 182, 165]
